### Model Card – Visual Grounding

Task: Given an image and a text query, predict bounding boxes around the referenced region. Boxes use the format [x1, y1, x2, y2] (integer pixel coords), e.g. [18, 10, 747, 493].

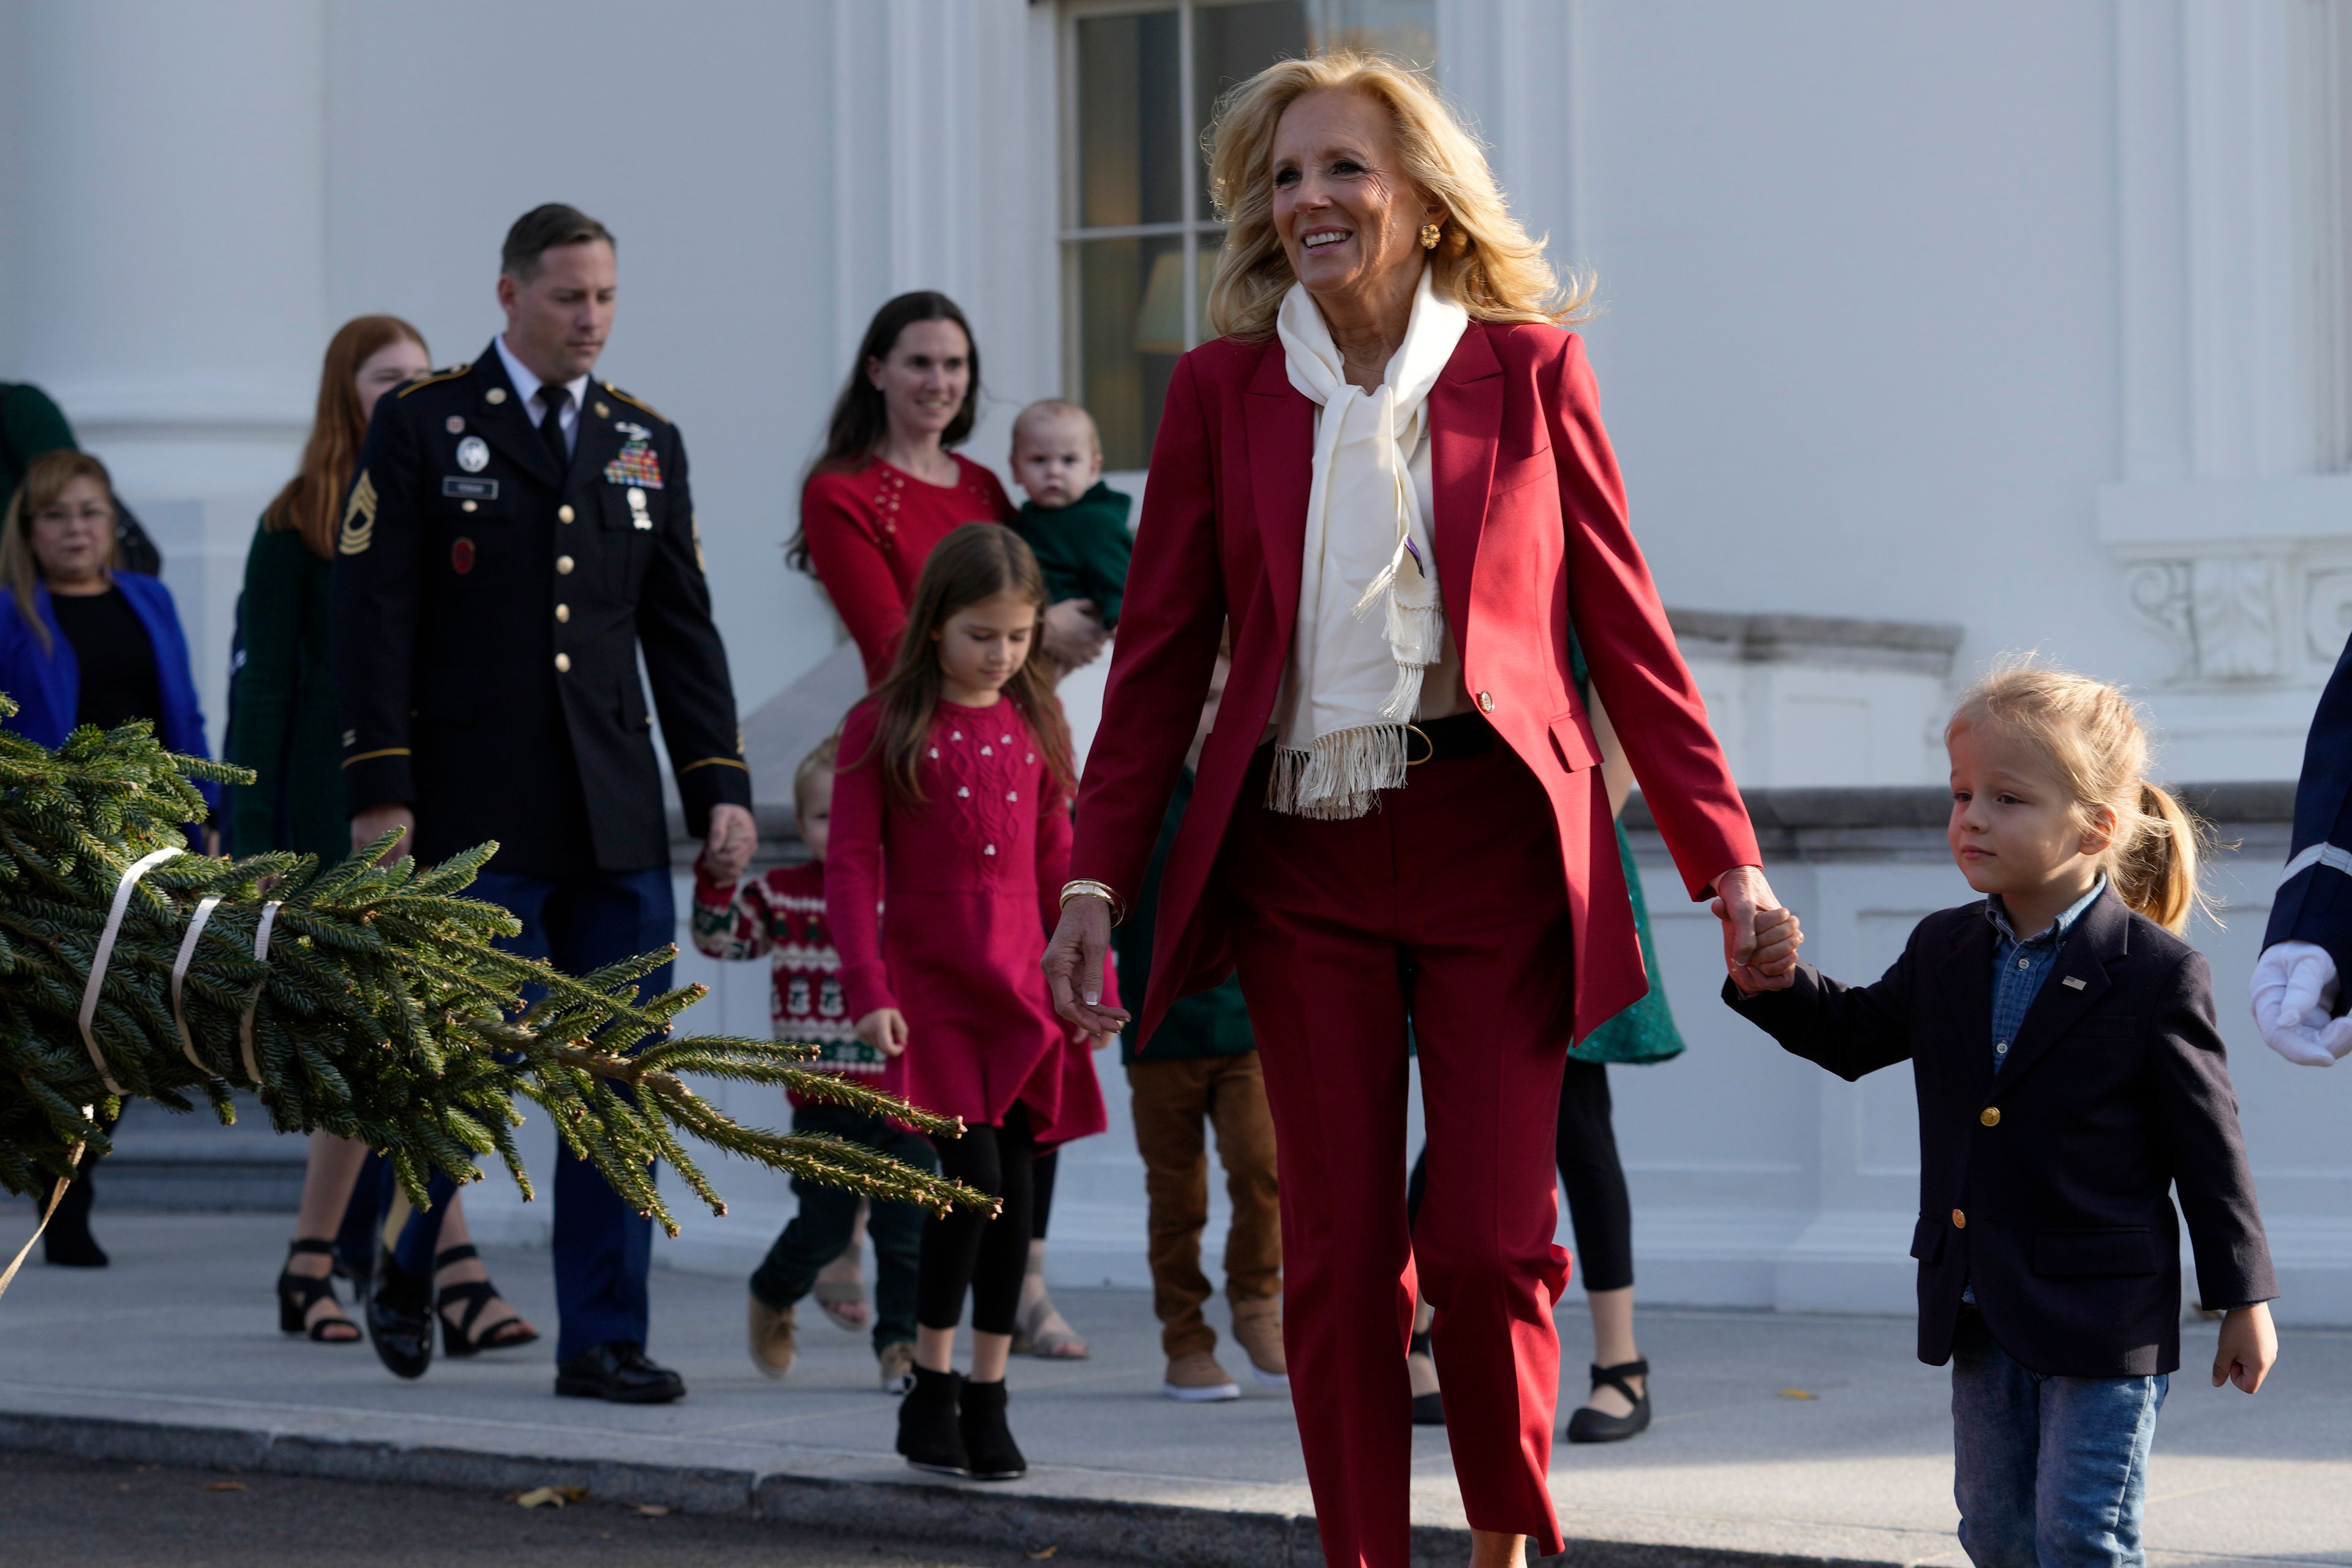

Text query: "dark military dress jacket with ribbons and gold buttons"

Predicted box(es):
[334, 345, 750, 877]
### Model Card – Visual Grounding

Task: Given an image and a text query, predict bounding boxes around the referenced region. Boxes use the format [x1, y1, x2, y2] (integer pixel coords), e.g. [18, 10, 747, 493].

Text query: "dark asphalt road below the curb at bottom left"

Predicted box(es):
[0, 1458, 1124, 1568]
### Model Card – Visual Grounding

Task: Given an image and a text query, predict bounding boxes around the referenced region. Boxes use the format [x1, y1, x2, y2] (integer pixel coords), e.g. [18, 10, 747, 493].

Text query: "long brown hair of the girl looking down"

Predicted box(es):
[846, 522, 1077, 804]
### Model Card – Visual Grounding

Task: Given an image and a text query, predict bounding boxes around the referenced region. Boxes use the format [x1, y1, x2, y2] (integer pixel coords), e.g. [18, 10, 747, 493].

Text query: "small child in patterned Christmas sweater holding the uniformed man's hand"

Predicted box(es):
[694, 738, 938, 1394]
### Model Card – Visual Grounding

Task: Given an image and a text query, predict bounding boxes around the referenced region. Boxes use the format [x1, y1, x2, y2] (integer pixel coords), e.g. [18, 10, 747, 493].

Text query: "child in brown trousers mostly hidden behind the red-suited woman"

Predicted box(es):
[1112, 656, 1289, 1401]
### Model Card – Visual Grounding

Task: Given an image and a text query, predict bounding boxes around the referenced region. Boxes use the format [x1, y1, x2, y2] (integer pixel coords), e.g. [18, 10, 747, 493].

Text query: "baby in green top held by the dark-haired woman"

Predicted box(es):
[1014, 399, 1134, 677]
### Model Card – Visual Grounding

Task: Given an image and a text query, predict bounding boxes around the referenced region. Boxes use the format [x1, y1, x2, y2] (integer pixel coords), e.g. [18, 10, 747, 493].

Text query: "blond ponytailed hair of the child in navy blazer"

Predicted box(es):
[1943, 656, 2213, 936]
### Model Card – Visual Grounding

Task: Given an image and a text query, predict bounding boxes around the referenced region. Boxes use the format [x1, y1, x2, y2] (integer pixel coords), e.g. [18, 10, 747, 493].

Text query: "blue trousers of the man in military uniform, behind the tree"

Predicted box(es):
[379, 865, 677, 1361]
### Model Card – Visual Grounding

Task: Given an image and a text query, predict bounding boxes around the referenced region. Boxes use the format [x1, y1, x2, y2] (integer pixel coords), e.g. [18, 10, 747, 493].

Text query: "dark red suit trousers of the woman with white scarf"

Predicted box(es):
[1221, 741, 1571, 1568]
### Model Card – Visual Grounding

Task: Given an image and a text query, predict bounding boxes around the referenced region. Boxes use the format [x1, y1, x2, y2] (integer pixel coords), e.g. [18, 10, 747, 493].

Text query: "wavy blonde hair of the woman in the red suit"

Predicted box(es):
[1207, 50, 1593, 341]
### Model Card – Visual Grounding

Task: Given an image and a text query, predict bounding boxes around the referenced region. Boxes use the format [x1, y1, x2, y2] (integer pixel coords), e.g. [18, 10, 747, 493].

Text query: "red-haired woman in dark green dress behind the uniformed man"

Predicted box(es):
[226, 315, 538, 1354]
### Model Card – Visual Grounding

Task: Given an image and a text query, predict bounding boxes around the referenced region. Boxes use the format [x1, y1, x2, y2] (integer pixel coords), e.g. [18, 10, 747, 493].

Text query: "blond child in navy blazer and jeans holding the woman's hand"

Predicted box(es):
[1724, 665, 2279, 1568]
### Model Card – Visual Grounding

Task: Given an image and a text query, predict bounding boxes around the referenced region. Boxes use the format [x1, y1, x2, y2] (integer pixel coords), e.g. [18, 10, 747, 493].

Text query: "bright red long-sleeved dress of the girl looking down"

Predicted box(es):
[826, 701, 1103, 1145]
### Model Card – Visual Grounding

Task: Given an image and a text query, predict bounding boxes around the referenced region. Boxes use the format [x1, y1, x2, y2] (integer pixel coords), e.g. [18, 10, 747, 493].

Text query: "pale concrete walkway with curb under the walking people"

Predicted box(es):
[0, 1208, 2352, 1568]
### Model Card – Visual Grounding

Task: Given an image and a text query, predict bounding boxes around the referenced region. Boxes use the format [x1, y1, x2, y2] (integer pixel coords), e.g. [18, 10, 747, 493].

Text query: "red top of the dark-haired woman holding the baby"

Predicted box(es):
[800, 451, 1014, 687]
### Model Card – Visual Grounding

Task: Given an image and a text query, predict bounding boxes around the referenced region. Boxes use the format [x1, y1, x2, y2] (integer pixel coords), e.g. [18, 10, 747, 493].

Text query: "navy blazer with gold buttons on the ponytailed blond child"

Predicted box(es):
[1724, 886, 2279, 1378]
